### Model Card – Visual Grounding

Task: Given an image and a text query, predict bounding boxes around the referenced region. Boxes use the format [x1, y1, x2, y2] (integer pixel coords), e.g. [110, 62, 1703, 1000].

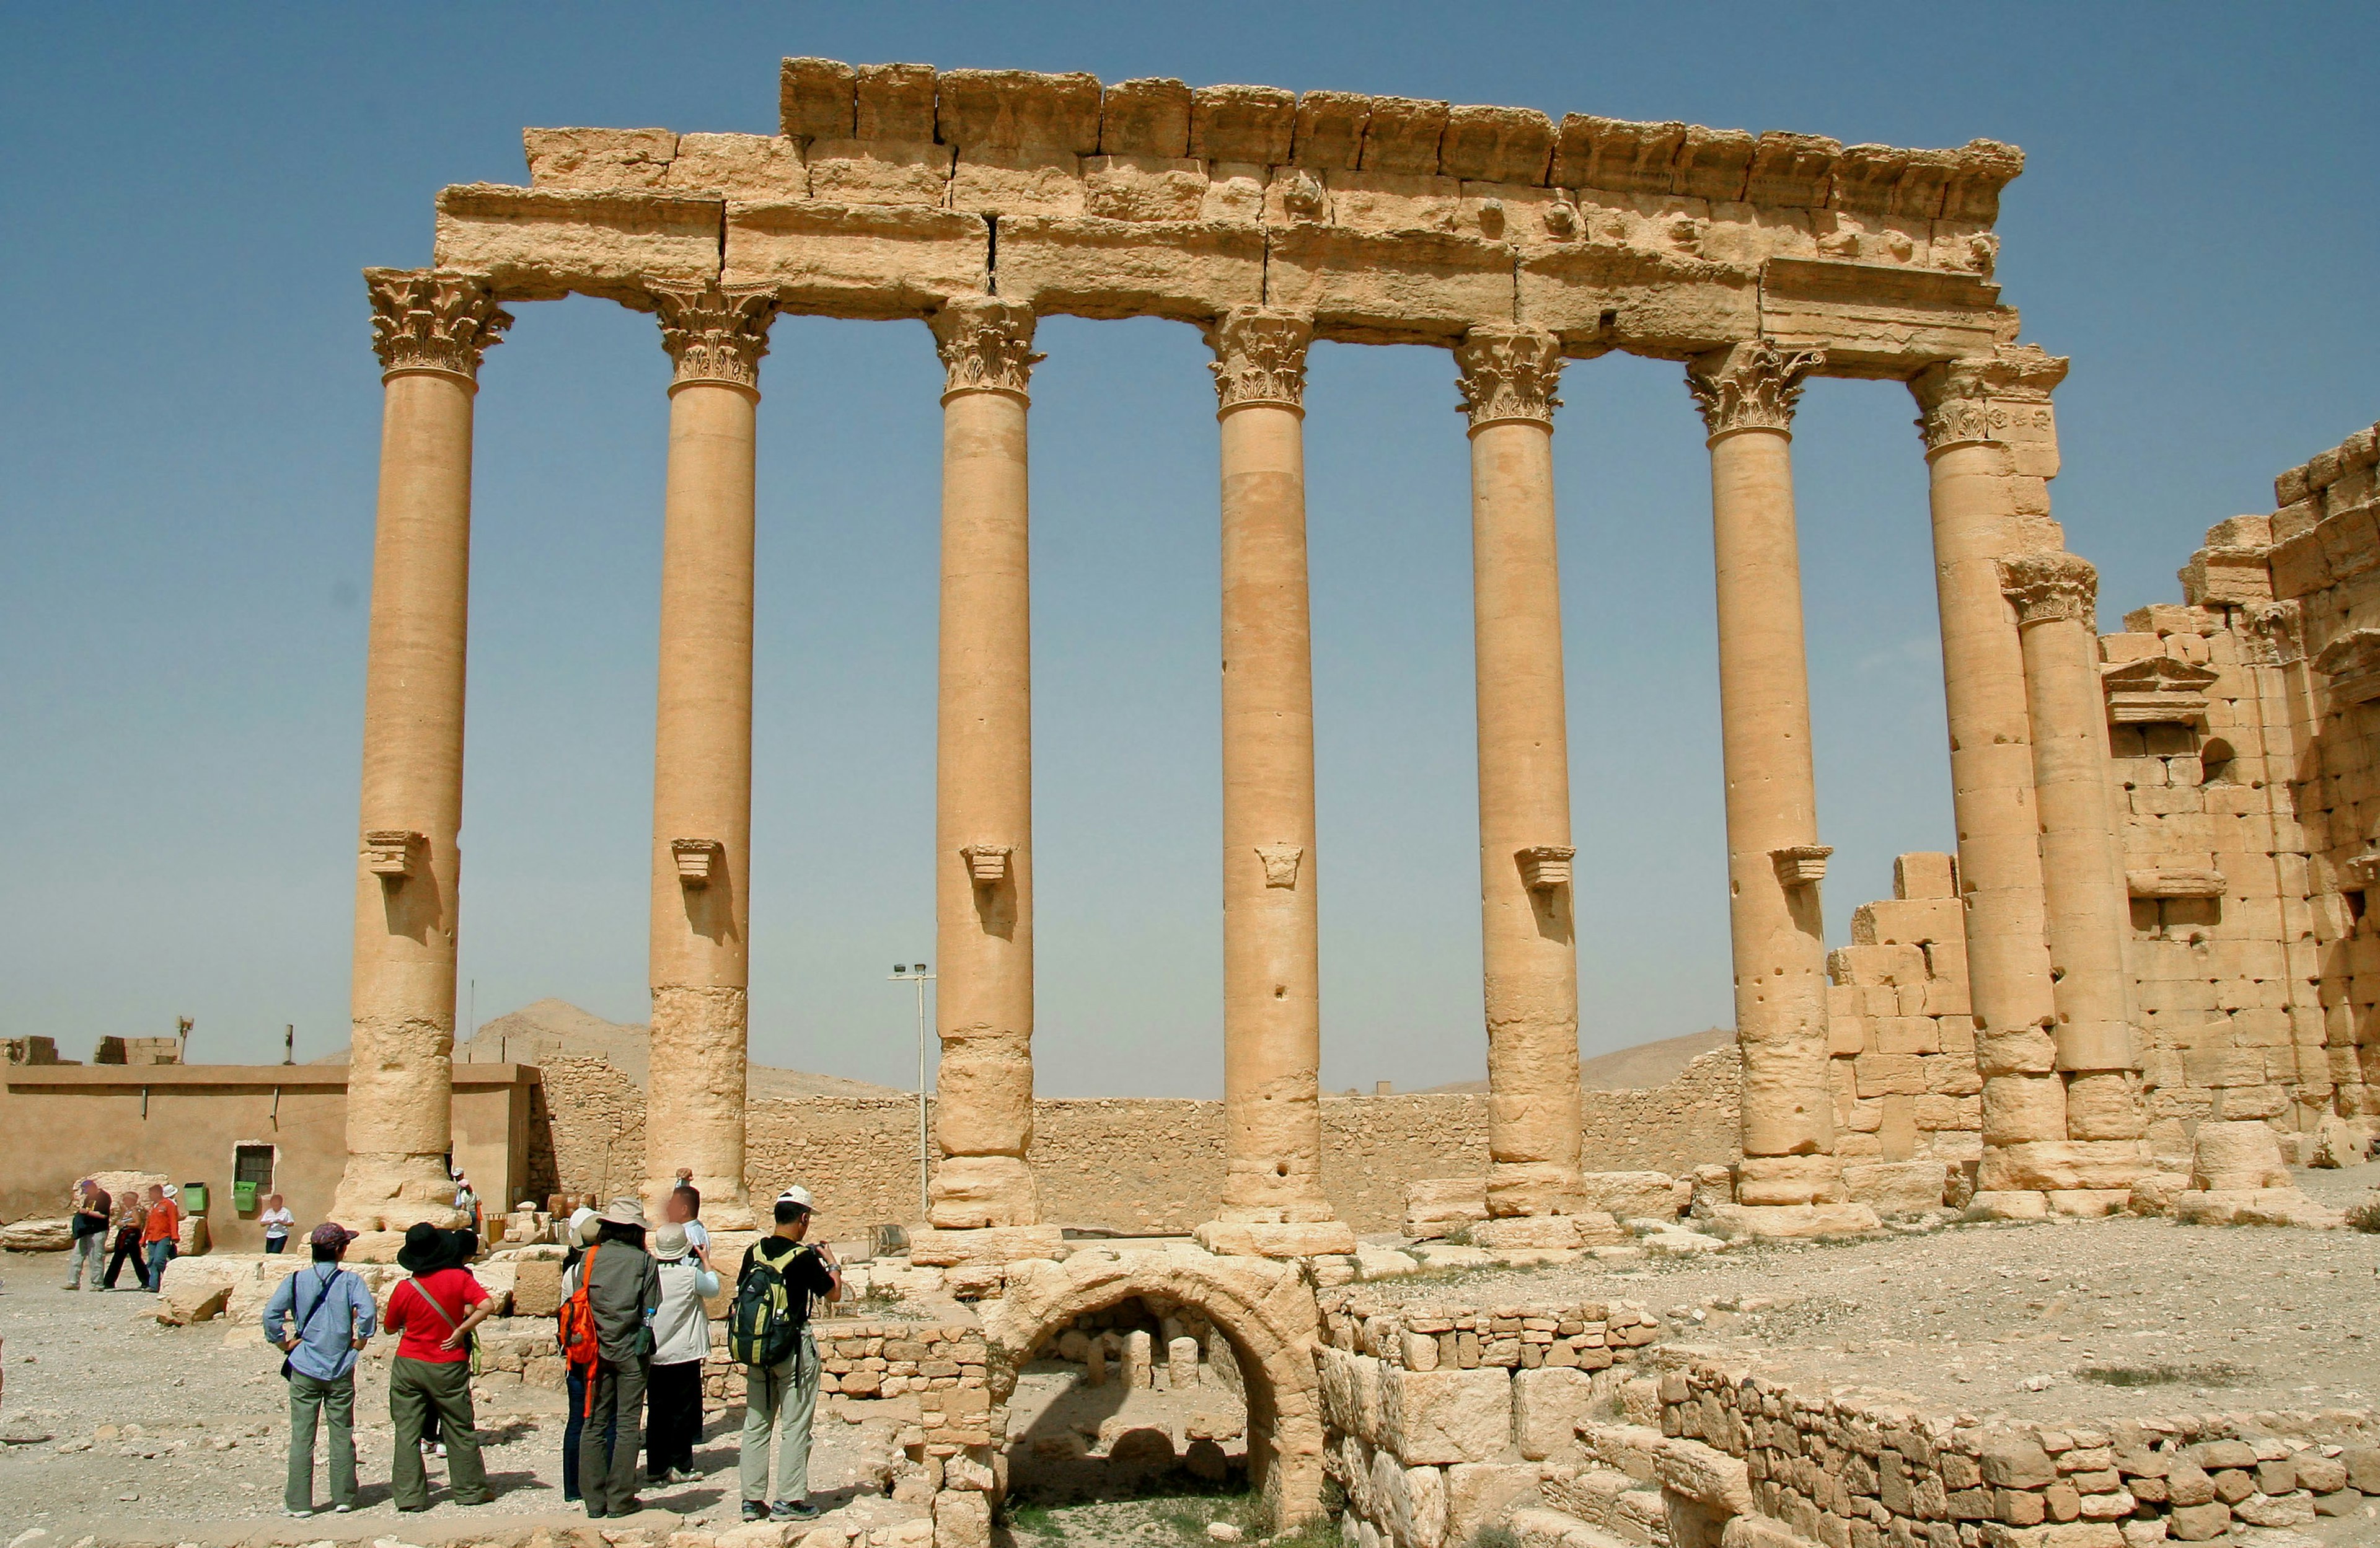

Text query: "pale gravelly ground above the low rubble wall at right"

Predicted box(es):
[1371, 1165, 2380, 1420]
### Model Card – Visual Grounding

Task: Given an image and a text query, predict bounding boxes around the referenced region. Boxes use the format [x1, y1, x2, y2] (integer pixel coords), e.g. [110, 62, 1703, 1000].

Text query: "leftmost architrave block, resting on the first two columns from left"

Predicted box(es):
[436, 183, 723, 307]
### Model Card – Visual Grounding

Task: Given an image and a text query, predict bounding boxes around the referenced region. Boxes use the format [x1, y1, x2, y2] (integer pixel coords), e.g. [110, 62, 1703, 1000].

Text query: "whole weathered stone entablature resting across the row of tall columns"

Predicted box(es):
[423, 59, 2023, 376]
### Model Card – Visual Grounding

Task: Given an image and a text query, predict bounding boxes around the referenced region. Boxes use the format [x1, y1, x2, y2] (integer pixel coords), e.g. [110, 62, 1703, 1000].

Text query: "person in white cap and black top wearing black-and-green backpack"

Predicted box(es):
[728, 1189, 842, 1522]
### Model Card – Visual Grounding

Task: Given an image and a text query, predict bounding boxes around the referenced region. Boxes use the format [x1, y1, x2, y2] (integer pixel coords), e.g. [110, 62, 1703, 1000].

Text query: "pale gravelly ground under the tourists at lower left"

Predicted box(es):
[0, 1253, 919, 1548]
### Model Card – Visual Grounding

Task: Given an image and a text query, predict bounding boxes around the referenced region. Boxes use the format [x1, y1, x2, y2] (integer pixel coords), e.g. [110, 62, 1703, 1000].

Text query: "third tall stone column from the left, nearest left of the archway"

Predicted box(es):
[926, 295, 1040, 1227]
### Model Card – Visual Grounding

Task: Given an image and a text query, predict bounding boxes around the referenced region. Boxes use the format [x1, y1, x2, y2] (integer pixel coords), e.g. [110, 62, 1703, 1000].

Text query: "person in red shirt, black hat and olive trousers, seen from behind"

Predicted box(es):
[381, 1222, 495, 1510]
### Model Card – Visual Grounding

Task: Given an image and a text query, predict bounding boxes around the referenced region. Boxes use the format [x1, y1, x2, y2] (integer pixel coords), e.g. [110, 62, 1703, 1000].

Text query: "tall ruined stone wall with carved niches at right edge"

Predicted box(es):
[2099, 418, 2380, 1165]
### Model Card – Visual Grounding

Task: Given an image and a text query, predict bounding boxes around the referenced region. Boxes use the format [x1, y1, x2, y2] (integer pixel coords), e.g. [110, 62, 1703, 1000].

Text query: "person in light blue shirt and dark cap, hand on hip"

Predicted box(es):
[264, 1220, 379, 1517]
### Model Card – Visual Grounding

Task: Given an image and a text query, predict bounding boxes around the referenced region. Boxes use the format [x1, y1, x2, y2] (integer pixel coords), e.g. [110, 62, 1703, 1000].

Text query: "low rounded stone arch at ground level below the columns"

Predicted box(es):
[981, 1249, 1326, 1526]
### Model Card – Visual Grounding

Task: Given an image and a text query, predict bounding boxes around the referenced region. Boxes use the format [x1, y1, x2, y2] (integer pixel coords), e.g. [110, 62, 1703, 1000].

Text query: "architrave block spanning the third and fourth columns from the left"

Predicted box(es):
[1000, 215, 1264, 321]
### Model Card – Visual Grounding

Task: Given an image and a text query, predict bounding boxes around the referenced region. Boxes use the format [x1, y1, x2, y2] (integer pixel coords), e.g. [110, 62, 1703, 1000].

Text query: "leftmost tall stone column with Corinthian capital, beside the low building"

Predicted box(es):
[331, 269, 512, 1232]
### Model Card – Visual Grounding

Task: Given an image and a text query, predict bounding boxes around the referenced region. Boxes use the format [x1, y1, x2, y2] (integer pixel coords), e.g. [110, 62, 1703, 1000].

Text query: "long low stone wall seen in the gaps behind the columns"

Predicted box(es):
[545, 1049, 1740, 1239]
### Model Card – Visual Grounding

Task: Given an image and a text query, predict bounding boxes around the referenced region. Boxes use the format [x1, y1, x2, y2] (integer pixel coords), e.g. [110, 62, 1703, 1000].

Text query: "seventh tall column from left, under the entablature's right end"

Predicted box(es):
[1911, 350, 2066, 1203]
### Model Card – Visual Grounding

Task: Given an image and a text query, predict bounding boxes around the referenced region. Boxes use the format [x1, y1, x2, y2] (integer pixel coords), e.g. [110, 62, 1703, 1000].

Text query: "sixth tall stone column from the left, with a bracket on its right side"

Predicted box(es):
[1685, 340, 1842, 1205]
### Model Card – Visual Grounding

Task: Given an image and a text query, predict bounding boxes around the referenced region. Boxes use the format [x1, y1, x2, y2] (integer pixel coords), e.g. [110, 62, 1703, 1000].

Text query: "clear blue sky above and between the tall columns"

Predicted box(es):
[0, 2, 2380, 1096]
